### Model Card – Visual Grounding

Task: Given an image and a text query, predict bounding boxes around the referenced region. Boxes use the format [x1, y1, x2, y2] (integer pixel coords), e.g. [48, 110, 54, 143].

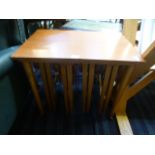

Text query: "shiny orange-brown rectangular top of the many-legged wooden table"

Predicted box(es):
[12, 30, 144, 63]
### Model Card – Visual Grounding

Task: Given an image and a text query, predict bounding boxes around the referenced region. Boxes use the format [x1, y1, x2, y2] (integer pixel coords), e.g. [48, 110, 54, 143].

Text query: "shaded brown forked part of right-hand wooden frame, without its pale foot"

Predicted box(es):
[113, 42, 155, 112]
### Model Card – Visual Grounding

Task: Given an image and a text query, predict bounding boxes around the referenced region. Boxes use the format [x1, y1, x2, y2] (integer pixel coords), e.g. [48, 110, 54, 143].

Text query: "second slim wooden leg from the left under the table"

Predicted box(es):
[39, 63, 51, 108]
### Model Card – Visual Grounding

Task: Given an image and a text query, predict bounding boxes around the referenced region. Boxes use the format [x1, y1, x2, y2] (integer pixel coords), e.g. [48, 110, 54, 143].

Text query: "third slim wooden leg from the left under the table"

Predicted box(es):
[45, 63, 56, 109]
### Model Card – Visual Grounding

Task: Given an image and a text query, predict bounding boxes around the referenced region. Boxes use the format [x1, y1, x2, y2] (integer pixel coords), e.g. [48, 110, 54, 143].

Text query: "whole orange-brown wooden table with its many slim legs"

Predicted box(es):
[12, 30, 144, 133]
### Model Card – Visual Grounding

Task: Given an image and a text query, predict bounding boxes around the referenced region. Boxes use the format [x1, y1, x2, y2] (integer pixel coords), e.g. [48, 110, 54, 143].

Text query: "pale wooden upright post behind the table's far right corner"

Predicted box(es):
[123, 19, 138, 45]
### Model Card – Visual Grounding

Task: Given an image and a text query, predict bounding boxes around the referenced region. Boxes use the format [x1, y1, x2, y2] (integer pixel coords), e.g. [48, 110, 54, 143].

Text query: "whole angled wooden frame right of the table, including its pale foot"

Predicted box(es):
[112, 41, 155, 134]
